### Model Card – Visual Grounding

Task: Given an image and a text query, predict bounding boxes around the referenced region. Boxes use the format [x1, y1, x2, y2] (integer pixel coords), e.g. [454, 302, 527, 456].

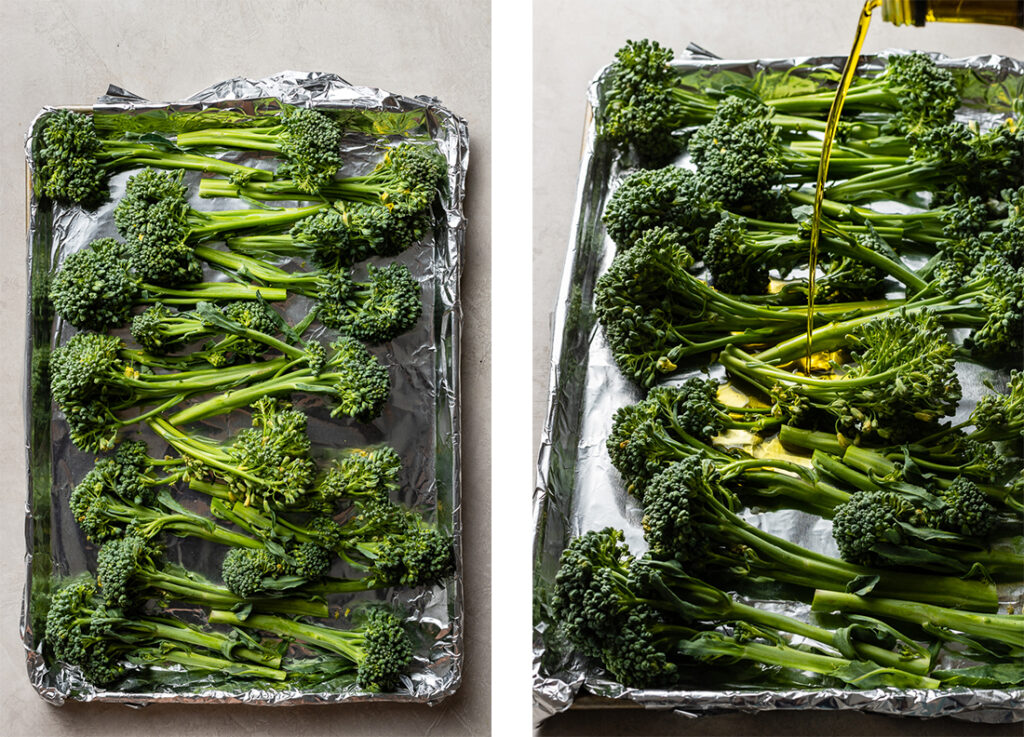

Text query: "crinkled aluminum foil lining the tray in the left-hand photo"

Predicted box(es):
[20, 72, 469, 704]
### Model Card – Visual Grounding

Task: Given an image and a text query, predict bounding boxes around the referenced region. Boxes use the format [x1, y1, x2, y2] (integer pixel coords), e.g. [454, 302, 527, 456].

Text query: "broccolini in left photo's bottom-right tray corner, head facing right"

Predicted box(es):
[209, 608, 413, 691]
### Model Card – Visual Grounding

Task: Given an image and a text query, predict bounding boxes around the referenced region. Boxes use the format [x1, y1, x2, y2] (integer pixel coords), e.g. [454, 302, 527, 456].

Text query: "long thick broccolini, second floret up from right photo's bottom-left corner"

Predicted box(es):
[642, 457, 997, 611]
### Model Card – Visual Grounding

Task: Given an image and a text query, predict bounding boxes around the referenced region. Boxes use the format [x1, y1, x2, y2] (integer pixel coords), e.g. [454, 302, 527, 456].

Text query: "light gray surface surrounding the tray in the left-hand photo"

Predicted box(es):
[0, 0, 491, 737]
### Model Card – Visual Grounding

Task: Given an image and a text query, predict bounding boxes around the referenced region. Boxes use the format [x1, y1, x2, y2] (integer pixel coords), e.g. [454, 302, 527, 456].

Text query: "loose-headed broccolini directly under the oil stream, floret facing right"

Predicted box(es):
[720, 312, 961, 439]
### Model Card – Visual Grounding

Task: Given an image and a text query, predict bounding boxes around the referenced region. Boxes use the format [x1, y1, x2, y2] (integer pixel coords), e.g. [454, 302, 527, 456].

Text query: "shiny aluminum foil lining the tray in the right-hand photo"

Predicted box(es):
[534, 44, 1024, 723]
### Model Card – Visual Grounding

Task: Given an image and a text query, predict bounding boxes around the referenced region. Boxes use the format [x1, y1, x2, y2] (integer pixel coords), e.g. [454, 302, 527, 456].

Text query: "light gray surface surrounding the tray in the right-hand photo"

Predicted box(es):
[536, 0, 1024, 735]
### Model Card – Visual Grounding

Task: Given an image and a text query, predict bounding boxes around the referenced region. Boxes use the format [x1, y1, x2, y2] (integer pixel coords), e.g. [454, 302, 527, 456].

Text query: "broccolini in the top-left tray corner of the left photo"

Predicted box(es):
[32, 110, 271, 209]
